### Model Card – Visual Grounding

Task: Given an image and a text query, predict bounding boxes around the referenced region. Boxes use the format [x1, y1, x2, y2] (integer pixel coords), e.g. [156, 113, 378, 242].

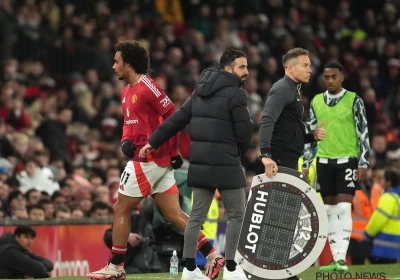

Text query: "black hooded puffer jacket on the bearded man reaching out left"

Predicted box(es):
[149, 69, 254, 189]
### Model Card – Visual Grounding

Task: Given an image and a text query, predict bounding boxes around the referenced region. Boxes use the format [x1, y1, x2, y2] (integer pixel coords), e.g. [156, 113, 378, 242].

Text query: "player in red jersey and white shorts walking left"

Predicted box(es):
[87, 41, 224, 279]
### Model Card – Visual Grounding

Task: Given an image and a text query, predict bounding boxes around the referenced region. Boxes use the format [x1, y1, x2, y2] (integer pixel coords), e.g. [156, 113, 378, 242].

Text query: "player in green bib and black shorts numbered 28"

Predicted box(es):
[303, 62, 370, 271]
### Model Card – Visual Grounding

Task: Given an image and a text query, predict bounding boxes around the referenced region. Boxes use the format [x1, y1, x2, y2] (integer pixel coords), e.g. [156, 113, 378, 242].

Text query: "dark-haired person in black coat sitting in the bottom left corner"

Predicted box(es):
[0, 226, 53, 279]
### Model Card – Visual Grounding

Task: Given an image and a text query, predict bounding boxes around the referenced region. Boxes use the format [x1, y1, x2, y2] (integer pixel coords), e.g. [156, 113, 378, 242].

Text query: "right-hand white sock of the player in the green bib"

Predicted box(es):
[333, 202, 353, 261]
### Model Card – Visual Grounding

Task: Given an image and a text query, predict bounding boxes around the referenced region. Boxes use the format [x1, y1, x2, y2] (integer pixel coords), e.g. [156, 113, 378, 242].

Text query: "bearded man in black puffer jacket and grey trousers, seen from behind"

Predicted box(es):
[140, 50, 254, 280]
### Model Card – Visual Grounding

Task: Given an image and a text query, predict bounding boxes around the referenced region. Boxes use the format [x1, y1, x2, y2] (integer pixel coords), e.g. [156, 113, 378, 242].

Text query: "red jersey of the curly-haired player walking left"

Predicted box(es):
[121, 75, 178, 167]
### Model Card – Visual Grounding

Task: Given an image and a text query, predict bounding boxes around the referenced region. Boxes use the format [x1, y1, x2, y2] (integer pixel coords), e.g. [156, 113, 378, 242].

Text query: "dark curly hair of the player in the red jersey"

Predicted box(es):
[115, 40, 150, 74]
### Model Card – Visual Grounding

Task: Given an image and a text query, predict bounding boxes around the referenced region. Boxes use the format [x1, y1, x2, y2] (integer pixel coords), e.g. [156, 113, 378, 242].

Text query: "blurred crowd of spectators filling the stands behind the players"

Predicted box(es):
[0, 0, 400, 266]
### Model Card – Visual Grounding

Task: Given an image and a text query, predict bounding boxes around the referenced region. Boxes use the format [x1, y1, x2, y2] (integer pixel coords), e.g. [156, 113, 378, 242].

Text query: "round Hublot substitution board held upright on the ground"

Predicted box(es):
[235, 167, 328, 280]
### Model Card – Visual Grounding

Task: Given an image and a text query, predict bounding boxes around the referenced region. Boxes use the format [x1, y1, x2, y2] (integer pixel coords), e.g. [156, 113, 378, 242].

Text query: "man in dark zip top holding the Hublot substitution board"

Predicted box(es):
[260, 48, 325, 280]
